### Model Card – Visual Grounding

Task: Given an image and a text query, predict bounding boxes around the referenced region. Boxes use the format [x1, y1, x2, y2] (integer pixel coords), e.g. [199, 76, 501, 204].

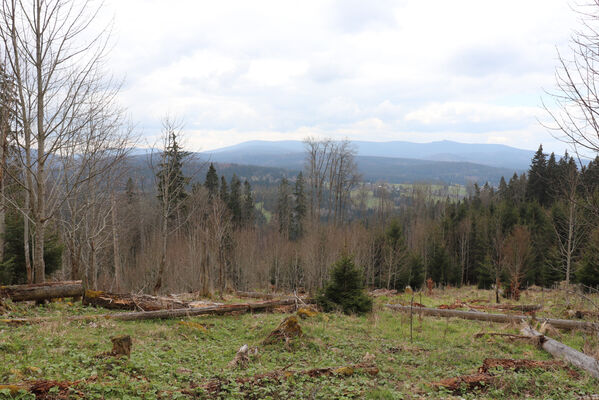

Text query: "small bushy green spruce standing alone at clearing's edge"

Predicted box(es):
[316, 256, 372, 314]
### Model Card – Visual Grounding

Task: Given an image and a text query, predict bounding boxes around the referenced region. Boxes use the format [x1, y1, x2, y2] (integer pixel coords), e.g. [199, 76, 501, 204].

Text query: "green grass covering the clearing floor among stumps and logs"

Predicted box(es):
[0, 289, 598, 399]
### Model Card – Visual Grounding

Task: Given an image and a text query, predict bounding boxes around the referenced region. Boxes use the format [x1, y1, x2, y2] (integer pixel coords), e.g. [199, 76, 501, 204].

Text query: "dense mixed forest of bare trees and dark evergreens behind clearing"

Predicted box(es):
[0, 121, 599, 296]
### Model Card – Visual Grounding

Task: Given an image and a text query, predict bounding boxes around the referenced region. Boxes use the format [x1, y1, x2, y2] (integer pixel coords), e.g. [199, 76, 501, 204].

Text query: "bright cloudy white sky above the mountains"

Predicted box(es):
[104, 0, 578, 152]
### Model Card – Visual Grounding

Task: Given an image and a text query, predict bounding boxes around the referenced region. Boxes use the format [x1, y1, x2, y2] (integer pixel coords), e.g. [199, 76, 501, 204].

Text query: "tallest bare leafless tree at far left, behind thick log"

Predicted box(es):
[0, 0, 123, 282]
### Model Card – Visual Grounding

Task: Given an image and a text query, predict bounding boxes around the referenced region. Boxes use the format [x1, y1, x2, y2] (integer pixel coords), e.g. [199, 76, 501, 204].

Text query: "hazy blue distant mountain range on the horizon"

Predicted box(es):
[201, 140, 534, 185]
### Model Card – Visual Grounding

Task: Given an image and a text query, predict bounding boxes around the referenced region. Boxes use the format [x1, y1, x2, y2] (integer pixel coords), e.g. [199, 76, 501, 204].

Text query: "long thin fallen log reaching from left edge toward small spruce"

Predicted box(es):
[0, 299, 311, 325]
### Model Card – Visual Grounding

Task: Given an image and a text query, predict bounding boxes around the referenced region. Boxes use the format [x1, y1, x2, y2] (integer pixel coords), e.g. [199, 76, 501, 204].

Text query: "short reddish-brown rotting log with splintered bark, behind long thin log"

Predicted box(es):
[83, 290, 190, 311]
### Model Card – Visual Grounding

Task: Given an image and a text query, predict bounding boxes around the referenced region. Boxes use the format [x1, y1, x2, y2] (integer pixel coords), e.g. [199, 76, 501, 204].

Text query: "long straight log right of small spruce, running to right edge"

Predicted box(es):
[385, 304, 599, 331]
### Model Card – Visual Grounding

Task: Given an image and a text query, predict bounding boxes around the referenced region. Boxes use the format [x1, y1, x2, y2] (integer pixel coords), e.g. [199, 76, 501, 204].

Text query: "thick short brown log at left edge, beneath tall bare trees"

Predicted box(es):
[0, 281, 83, 301]
